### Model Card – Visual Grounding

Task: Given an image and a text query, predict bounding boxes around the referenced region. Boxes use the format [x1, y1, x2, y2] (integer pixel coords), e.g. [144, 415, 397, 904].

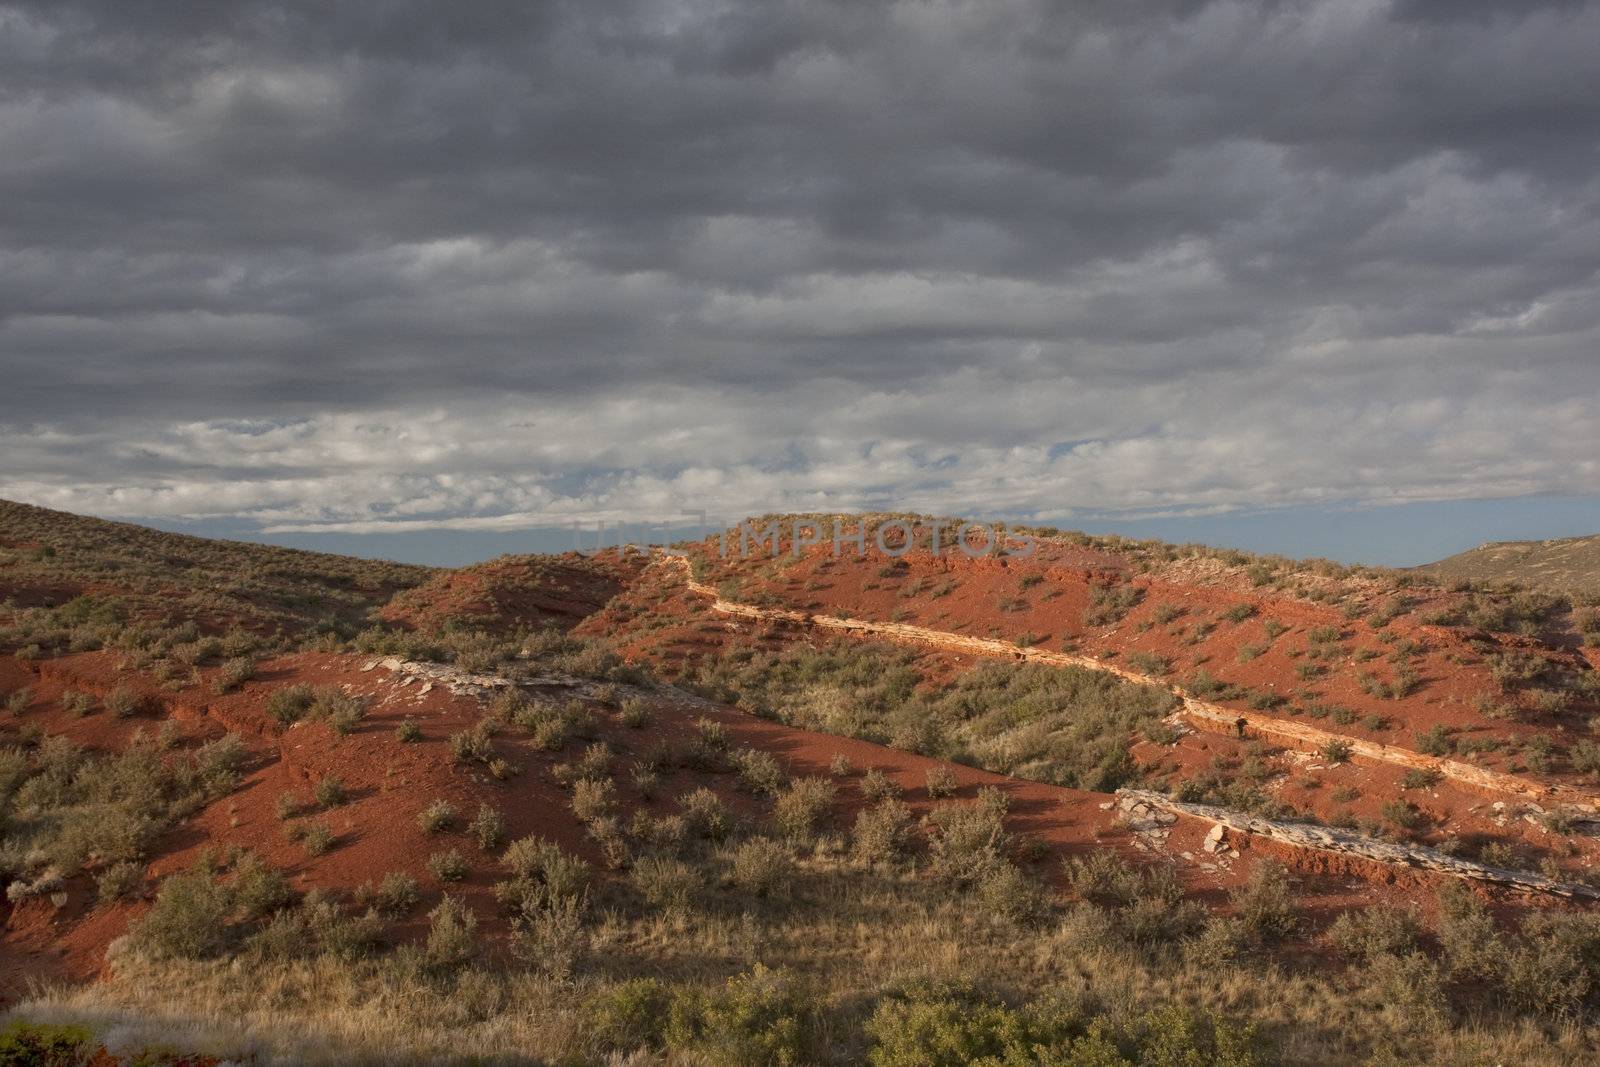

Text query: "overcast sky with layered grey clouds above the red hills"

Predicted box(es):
[0, 0, 1600, 563]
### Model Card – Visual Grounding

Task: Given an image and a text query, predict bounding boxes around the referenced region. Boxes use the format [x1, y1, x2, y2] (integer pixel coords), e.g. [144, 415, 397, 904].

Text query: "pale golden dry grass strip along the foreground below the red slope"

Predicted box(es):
[13, 846, 1597, 1064]
